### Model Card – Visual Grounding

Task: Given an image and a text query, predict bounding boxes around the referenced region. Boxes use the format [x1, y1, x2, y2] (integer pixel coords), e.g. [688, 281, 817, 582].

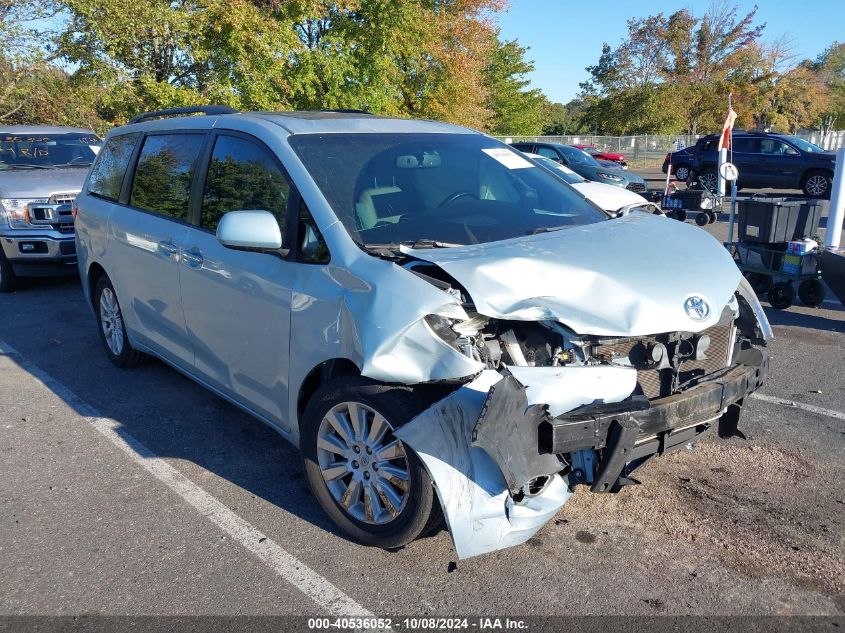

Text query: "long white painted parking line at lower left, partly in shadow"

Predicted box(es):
[0, 340, 372, 617]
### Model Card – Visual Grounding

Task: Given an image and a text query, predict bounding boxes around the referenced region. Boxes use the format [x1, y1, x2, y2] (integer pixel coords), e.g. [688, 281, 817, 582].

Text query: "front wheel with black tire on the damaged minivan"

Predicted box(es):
[300, 377, 443, 549]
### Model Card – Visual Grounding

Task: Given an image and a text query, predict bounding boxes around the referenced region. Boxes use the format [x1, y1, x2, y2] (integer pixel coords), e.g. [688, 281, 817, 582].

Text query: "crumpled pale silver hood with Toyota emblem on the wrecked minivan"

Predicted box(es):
[406, 213, 740, 336]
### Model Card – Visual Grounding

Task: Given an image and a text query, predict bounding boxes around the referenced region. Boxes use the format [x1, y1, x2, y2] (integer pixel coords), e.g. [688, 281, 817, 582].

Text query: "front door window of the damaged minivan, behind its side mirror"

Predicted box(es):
[200, 136, 290, 235]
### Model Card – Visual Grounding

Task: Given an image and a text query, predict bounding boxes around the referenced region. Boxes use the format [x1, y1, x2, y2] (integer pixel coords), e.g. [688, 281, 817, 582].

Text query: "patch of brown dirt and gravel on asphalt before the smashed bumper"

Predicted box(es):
[566, 441, 845, 600]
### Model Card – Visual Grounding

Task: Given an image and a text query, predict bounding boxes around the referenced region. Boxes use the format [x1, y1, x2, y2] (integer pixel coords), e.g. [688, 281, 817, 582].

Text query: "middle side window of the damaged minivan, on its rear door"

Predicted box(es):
[129, 134, 205, 221]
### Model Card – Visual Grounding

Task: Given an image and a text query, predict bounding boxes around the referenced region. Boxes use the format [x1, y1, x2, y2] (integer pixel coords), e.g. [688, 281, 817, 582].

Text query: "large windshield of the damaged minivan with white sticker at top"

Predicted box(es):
[290, 134, 607, 246]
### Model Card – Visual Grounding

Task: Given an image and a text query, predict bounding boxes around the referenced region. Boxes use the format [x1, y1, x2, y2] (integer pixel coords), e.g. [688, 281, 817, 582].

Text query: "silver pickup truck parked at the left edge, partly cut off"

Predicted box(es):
[0, 125, 102, 291]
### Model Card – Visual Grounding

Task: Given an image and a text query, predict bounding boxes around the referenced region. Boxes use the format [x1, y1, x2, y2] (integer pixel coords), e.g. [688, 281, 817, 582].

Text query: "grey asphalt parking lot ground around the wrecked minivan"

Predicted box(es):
[0, 196, 845, 616]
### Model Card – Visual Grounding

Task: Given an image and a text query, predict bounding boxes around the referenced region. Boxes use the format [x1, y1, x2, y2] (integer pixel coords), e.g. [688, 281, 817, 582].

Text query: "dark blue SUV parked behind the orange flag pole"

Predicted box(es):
[684, 132, 836, 198]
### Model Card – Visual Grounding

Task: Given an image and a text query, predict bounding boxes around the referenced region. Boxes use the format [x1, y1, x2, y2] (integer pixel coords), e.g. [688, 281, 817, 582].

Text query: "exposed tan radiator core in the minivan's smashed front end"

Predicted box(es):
[593, 317, 733, 400]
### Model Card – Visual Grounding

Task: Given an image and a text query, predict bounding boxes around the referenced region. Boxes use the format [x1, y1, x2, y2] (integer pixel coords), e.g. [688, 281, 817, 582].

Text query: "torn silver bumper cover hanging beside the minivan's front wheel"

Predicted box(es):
[395, 370, 571, 559]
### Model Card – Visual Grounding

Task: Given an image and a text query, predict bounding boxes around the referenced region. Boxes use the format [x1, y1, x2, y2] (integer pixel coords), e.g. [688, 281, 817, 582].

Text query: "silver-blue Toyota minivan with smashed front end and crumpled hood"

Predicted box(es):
[76, 107, 771, 558]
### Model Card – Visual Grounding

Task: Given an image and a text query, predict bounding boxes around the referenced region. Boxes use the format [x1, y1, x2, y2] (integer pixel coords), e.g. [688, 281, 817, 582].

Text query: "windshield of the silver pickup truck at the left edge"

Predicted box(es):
[0, 132, 103, 170]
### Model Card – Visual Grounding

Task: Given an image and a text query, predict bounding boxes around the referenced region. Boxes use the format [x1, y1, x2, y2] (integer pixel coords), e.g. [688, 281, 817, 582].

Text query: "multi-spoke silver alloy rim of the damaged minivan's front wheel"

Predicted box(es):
[317, 402, 410, 525]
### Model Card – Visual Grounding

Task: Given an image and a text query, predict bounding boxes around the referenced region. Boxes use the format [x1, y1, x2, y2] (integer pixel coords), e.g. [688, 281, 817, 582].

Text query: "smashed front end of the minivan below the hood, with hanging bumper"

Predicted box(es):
[396, 254, 771, 558]
